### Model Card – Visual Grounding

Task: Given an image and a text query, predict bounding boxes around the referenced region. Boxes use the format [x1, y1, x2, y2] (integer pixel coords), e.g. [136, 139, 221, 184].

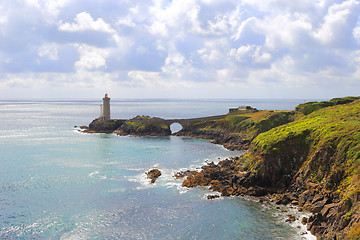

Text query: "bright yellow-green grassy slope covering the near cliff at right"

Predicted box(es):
[249, 101, 360, 197]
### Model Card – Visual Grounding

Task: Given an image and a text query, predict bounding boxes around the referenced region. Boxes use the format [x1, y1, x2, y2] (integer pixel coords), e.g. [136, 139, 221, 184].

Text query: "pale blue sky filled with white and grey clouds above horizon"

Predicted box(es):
[0, 0, 360, 99]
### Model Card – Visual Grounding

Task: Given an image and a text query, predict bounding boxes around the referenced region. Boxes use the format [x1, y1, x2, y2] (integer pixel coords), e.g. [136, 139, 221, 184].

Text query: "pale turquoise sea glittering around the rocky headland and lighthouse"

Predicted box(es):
[0, 98, 315, 240]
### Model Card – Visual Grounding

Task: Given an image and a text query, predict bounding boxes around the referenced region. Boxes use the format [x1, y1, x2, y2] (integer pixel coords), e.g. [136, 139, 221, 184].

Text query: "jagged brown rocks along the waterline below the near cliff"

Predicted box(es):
[175, 158, 352, 239]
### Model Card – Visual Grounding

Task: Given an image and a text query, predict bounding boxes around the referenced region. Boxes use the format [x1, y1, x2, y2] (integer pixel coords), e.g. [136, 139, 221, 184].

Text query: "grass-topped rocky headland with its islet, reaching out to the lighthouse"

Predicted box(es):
[83, 97, 360, 239]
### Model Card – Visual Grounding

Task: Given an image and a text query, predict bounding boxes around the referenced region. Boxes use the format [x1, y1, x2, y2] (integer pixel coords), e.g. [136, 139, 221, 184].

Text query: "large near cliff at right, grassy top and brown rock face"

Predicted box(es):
[237, 101, 360, 239]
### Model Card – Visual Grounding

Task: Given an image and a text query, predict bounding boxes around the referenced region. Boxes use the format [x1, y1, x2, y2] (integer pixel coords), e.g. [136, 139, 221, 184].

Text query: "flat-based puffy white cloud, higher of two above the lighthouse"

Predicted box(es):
[59, 12, 115, 33]
